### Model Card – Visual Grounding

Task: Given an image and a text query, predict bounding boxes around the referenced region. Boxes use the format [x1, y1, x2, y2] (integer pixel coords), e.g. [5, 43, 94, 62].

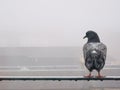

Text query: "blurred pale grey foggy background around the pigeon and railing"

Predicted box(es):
[0, 0, 120, 90]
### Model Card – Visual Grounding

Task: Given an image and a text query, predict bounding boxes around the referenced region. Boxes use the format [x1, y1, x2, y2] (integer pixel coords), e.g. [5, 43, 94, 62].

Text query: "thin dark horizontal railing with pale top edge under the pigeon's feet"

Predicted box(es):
[0, 76, 120, 81]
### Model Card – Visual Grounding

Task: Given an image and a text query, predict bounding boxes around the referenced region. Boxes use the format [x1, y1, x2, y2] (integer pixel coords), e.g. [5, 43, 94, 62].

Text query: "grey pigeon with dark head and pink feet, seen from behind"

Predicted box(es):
[83, 30, 107, 78]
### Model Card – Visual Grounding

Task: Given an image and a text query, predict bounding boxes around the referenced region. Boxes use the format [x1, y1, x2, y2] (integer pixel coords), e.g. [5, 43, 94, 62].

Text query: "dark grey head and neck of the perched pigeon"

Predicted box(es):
[84, 31, 100, 43]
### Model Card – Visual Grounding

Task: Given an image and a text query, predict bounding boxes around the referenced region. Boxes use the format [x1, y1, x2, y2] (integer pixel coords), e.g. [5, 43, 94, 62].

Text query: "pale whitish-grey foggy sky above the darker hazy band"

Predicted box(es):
[0, 0, 120, 48]
